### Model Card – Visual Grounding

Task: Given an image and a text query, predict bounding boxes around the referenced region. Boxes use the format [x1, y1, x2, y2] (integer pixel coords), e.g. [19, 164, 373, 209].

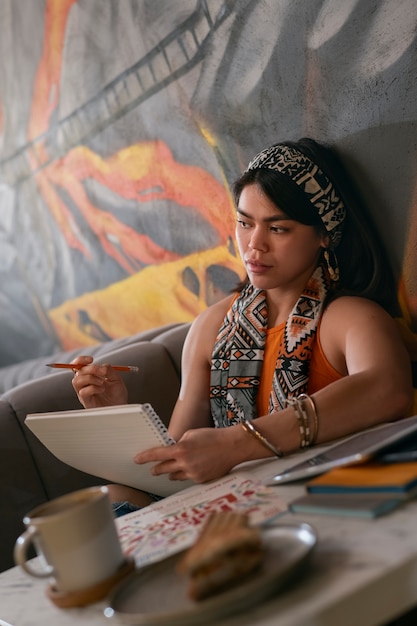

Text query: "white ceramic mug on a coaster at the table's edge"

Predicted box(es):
[14, 486, 125, 593]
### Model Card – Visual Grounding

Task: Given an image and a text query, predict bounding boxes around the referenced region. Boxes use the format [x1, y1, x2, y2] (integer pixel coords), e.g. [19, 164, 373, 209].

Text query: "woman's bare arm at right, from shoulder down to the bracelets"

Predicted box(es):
[298, 297, 412, 442]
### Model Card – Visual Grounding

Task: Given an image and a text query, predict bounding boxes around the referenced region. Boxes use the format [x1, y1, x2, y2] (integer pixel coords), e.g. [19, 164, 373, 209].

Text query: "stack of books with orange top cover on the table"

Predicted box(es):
[290, 460, 417, 518]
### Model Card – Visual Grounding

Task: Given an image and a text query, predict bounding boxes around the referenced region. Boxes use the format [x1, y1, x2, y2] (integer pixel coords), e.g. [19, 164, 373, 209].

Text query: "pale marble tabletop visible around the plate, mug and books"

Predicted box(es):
[0, 451, 417, 626]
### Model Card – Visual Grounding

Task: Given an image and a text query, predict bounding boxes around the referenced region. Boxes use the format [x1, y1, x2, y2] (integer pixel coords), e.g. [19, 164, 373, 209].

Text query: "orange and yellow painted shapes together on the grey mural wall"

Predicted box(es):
[22, 0, 242, 349]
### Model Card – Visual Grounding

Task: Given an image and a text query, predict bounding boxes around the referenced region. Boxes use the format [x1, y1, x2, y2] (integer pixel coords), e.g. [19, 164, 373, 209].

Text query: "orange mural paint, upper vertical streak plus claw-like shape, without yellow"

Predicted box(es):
[24, 0, 234, 273]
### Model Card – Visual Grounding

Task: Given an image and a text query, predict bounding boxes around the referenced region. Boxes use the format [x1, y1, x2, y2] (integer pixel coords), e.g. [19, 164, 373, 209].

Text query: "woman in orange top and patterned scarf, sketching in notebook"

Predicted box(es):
[73, 139, 412, 506]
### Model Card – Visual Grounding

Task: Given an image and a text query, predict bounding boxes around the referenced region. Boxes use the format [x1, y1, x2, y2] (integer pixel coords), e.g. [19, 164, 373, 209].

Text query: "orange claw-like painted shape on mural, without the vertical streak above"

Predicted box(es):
[48, 141, 235, 273]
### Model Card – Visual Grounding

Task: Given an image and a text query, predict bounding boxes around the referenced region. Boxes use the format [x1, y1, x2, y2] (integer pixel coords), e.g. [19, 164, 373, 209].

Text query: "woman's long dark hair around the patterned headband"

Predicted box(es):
[233, 138, 400, 315]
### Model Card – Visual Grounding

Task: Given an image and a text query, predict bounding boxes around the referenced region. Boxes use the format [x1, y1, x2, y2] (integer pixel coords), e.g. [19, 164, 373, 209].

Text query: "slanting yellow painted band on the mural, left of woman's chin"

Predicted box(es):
[49, 246, 244, 350]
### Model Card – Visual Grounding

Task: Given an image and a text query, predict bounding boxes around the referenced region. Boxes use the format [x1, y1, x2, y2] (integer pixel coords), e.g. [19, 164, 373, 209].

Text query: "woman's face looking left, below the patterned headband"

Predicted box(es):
[236, 184, 328, 291]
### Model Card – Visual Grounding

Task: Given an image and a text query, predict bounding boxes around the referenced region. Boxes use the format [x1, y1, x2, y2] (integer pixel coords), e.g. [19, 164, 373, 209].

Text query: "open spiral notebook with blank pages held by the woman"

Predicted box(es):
[25, 404, 193, 496]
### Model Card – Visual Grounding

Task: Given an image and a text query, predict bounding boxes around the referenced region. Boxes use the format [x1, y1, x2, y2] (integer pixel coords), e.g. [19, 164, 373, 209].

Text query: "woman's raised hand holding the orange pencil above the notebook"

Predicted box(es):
[71, 356, 128, 409]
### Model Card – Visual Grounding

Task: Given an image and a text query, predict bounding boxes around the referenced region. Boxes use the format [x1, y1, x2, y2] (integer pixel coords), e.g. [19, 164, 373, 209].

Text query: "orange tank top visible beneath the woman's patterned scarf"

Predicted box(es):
[256, 322, 343, 415]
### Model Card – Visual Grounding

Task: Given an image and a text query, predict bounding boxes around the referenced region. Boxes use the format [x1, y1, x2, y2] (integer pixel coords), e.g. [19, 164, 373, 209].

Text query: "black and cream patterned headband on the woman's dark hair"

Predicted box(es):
[246, 144, 346, 248]
